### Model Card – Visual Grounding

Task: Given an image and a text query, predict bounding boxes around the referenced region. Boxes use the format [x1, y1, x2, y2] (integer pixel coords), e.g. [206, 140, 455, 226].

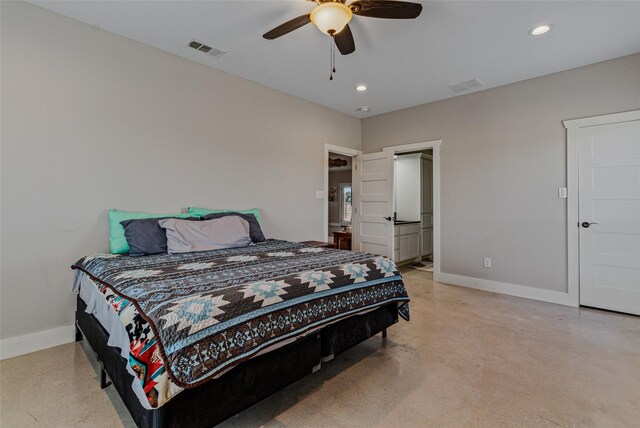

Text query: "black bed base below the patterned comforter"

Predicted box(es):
[75, 296, 398, 428]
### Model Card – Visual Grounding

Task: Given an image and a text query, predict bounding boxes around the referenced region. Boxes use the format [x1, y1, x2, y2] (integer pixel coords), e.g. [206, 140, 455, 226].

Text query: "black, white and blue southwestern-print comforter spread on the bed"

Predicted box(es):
[72, 240, 409, 407]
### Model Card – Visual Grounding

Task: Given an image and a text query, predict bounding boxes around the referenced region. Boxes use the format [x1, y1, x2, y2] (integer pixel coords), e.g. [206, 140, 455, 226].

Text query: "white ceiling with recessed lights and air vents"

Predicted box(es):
[30, 0, 640, 117]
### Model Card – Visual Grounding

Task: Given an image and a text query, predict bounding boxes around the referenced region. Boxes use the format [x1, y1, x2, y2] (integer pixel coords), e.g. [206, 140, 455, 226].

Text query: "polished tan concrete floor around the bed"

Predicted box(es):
[0, 269, 640, 428]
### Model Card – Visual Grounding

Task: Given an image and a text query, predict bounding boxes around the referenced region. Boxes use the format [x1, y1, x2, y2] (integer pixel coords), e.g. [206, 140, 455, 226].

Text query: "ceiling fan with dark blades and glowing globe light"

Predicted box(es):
[262, 0, 422, 55]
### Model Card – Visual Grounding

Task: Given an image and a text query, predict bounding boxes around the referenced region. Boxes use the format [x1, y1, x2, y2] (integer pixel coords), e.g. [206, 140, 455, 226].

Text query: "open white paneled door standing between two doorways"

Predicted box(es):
[352, 152, 393, 258]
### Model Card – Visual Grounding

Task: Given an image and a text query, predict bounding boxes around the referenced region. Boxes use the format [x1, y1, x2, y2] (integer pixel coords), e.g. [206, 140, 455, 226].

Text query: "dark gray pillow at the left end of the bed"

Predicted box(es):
[120, 217, 200, 256]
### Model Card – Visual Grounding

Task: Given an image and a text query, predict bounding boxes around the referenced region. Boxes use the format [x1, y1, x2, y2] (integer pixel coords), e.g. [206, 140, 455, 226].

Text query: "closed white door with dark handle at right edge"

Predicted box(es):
[578, 120, 640, 315]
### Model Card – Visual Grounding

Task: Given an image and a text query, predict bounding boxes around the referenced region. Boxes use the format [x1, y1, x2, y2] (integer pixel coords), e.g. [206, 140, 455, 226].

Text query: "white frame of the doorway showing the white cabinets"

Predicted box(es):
[382, 140, 442, 281]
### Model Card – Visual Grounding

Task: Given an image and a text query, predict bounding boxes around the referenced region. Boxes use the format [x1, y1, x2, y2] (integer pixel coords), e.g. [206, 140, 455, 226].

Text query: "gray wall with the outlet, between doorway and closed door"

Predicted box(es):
[362, 54, 640, 291]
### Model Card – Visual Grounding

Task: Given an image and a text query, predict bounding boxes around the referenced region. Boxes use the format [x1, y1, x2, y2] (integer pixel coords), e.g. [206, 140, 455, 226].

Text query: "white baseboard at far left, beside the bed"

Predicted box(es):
[0, 324, 75, 360]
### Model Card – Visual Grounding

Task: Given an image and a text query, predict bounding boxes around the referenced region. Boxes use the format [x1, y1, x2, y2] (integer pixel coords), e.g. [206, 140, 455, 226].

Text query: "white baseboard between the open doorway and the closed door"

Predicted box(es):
[436, 272, 578, 307]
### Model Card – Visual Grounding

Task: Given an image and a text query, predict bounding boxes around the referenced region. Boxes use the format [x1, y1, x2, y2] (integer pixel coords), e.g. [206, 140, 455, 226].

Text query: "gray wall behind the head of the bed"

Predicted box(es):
[0, 1, 361, 338]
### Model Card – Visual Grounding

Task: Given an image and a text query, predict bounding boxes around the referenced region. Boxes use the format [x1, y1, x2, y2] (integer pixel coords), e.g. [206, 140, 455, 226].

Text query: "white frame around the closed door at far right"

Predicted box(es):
[562, 110, 640, 307]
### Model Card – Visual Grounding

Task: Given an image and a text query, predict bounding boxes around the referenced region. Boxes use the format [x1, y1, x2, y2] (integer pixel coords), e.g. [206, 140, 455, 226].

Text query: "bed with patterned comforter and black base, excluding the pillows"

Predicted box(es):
[72, 239, 409, 427]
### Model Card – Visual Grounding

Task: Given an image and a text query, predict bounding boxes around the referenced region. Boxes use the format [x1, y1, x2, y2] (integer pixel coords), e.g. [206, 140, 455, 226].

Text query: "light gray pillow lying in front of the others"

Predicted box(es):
[159, 216, 251, 254]
